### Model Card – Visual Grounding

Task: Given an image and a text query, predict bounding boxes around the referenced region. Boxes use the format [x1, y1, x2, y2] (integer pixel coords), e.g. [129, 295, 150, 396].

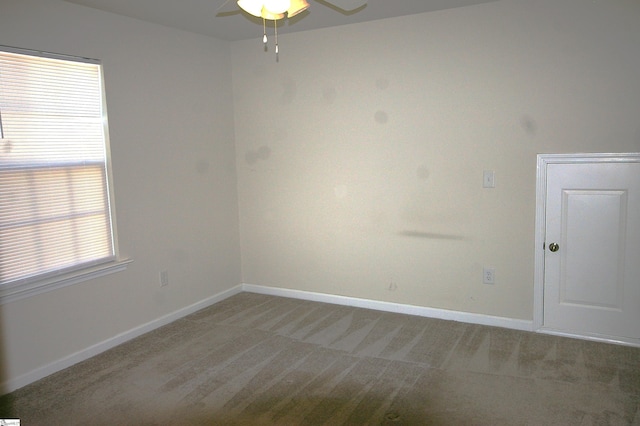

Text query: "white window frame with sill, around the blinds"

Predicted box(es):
[0, 45, 132, 305]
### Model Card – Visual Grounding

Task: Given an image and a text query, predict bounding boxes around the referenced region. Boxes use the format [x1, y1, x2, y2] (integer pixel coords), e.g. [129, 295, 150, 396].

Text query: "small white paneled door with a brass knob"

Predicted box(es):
[543, 158, 640, 344]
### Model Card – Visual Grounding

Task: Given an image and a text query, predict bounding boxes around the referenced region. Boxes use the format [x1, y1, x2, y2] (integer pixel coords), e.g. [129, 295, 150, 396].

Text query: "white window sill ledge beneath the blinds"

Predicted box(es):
[0, 259, 133, 305]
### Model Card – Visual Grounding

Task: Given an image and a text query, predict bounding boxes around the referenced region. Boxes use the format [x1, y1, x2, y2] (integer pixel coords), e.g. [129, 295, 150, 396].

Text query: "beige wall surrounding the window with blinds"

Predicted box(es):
[0, 0, 240, 392]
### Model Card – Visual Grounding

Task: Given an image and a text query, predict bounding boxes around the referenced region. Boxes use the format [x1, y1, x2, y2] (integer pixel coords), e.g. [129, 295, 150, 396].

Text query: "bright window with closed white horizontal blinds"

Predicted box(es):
[0, 46, 127, 298]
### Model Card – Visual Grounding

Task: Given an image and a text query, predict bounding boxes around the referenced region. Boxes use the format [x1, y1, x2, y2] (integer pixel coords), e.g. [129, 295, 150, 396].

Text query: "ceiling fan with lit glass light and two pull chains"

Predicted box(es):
[218, 0, 367, 55]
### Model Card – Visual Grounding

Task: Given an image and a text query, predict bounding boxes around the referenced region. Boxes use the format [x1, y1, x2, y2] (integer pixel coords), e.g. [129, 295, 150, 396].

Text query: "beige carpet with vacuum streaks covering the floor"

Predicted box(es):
[0, 293, 640, 426]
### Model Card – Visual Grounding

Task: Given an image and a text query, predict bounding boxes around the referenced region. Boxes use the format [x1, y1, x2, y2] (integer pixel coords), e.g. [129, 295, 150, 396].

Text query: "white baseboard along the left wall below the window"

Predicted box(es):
[0, 285, 242, 393]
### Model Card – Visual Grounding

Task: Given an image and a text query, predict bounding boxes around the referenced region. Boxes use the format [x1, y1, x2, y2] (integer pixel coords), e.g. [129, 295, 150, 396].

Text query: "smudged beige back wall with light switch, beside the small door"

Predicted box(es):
[232, 0, 640, 320]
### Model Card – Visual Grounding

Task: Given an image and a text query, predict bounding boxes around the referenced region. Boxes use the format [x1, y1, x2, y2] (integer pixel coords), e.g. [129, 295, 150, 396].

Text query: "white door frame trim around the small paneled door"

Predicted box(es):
[533, 153, 640, 346]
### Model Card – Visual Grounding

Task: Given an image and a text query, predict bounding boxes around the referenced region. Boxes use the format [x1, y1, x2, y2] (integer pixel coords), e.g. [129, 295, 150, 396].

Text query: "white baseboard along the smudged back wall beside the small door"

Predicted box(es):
[242, 284, 533, 331]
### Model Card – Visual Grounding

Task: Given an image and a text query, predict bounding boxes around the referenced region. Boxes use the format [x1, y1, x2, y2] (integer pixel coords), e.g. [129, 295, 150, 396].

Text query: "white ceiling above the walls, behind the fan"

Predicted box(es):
[66, 0, 497, 41]
